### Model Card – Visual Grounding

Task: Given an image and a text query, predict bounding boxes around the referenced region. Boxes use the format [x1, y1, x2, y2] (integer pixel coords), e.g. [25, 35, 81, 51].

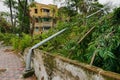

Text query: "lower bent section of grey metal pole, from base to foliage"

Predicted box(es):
[25, 28, 68, 71]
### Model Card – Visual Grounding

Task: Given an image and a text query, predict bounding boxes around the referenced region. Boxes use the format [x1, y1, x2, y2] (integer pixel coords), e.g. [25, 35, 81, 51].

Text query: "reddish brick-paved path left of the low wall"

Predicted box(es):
[0, 46, 36, 80]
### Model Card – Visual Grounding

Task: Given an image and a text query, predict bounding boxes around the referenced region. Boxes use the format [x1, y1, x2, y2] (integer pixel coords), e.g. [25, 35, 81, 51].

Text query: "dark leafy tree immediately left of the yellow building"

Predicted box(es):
[17, 0, 30, 34]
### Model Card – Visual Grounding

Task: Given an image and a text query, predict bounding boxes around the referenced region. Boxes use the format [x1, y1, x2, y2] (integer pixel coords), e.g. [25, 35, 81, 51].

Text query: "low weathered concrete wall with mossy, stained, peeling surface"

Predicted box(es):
[24, 50, 120, 80]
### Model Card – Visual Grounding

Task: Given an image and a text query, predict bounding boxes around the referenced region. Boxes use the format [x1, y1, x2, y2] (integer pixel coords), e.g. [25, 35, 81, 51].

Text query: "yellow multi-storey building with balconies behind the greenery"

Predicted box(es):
[30, 2, 57, 34]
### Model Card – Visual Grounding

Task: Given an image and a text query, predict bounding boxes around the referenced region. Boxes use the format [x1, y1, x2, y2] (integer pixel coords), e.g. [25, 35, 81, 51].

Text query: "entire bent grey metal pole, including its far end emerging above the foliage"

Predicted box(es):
[25, 7, 105, 72]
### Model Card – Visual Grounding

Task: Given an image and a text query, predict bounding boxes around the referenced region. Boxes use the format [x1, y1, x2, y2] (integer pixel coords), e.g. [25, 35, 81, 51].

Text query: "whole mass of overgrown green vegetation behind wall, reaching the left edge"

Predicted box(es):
[0, 0, 120, 73]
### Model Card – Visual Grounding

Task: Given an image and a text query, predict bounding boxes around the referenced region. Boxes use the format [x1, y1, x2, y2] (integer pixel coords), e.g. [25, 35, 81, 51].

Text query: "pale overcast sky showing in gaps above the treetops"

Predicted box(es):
[0, 0, 120, 11]
